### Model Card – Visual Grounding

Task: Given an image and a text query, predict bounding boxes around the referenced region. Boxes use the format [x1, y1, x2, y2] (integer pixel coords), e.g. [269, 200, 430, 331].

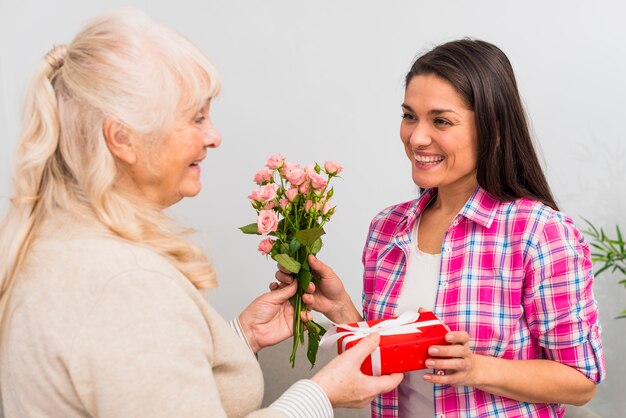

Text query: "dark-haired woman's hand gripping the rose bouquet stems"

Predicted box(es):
[270, 255, 362, 324]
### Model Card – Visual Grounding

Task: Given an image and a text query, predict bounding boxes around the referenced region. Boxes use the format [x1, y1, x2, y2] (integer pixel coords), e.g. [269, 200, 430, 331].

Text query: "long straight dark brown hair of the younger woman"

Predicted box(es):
[406, 39, 558, 210]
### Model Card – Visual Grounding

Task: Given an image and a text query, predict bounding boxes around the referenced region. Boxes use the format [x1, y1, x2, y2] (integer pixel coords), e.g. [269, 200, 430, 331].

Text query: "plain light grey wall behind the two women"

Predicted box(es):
[0, 0, 626, 417]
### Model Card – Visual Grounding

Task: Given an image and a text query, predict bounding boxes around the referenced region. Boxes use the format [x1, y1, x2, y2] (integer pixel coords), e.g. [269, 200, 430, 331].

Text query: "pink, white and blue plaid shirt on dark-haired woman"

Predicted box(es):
[363, 187, 605, 418]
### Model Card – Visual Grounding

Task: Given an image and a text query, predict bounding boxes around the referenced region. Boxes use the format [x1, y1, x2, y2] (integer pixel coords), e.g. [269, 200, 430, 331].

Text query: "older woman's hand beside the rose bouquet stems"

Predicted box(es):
[239, 281, 297, 353]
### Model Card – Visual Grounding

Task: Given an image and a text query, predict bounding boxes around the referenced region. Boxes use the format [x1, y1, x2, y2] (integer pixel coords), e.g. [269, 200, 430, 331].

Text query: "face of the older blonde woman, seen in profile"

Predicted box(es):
[131, 101, 222, 207]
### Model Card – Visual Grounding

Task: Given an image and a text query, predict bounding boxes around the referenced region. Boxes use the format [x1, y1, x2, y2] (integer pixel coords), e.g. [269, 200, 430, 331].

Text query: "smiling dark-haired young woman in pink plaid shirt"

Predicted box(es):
[272, 39, 605, 418]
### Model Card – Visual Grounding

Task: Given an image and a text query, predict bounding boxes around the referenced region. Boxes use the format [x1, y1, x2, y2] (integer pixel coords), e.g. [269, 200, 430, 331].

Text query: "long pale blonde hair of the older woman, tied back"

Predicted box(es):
[0, 10, 220, 319]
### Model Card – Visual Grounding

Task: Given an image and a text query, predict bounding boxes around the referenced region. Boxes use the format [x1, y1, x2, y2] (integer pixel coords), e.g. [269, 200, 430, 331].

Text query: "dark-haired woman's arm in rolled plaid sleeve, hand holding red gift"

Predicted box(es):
[427, 216, 604, 405]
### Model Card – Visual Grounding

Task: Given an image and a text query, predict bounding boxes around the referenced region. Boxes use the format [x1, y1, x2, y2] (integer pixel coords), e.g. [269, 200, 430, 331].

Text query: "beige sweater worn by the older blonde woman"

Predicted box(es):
[0, 219, 330, 418]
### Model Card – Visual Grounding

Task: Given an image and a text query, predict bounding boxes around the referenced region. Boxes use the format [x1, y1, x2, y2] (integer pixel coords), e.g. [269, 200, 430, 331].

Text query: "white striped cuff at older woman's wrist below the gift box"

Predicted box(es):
[271, 379, 333, 418]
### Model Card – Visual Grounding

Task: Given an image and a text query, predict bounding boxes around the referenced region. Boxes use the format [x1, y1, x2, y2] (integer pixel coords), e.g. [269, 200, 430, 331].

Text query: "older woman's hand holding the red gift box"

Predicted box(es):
[311, 334, 403, 408]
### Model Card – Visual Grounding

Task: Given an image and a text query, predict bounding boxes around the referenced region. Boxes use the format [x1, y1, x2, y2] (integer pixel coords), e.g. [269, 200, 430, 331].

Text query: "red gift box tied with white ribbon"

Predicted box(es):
[322, 311, 450, 376]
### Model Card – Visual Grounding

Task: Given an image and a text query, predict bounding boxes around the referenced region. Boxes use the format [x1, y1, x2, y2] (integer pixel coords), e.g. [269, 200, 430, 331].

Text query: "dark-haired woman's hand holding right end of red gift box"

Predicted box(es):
[424, 331, 481, 386]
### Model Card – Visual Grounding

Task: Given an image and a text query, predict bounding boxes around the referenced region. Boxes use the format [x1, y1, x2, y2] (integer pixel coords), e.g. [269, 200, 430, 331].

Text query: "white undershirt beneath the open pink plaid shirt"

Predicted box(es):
[395, 219, 441, 418]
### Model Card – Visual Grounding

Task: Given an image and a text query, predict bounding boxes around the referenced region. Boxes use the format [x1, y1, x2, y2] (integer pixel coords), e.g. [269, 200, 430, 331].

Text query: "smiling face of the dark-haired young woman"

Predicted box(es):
[400, 74, 478, 193]
